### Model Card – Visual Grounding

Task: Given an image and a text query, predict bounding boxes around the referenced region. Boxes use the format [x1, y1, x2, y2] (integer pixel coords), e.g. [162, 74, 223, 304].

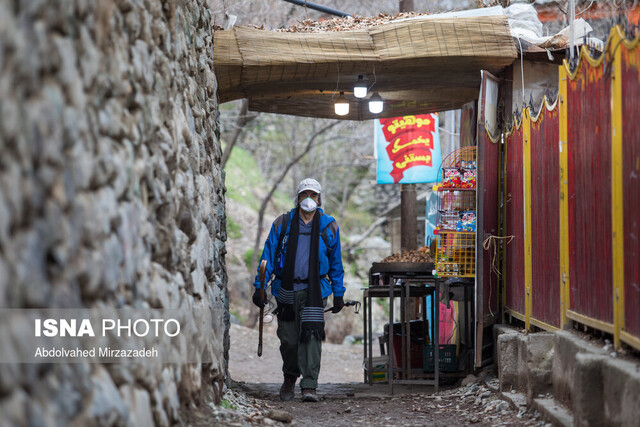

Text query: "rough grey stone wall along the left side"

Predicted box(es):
[0, 0, 229, 426]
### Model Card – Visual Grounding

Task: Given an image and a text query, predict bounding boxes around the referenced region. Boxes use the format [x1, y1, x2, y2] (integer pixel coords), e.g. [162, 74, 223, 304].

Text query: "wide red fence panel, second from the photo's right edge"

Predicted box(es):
[567, 60, 613, 323]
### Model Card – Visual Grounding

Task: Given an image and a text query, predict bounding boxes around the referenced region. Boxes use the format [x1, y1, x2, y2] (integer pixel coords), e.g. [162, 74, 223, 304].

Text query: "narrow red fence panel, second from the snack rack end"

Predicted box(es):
[505, 122, 525, 315]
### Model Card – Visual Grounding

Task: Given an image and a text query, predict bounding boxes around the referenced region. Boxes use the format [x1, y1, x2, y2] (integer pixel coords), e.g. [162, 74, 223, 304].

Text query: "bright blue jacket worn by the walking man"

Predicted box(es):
[253, 208, 345, 298]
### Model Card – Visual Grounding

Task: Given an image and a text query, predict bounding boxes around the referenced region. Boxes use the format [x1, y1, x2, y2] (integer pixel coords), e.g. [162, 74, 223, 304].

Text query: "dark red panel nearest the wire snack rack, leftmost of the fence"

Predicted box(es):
[476, 132, 500, 317]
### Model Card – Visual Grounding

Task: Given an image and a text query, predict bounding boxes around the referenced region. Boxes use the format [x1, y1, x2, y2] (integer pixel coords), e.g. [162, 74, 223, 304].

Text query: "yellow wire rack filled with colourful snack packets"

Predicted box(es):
[434, 146, 477, 277]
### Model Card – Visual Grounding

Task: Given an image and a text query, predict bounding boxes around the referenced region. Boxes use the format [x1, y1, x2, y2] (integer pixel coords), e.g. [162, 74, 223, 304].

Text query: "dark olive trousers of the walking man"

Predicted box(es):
[278, 289, 327, 388]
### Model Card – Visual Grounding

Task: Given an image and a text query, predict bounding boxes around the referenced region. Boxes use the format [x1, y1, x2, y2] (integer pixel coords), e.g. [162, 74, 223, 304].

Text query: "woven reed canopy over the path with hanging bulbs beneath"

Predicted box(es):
[214, 16, 516, 120]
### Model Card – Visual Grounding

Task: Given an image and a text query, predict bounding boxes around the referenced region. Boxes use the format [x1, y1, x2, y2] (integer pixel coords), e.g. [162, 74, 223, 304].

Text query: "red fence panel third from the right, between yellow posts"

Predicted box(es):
[531, 106, 560, 327]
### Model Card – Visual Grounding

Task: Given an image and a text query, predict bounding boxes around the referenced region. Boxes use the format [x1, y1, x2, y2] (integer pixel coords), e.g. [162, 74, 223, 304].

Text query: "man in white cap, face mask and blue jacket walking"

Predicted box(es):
[253, 178, 345, 402]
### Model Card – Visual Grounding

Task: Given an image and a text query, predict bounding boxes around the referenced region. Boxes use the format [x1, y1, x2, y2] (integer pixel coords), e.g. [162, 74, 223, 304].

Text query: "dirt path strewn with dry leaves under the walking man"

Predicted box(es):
[183, 325, 545, 427]
